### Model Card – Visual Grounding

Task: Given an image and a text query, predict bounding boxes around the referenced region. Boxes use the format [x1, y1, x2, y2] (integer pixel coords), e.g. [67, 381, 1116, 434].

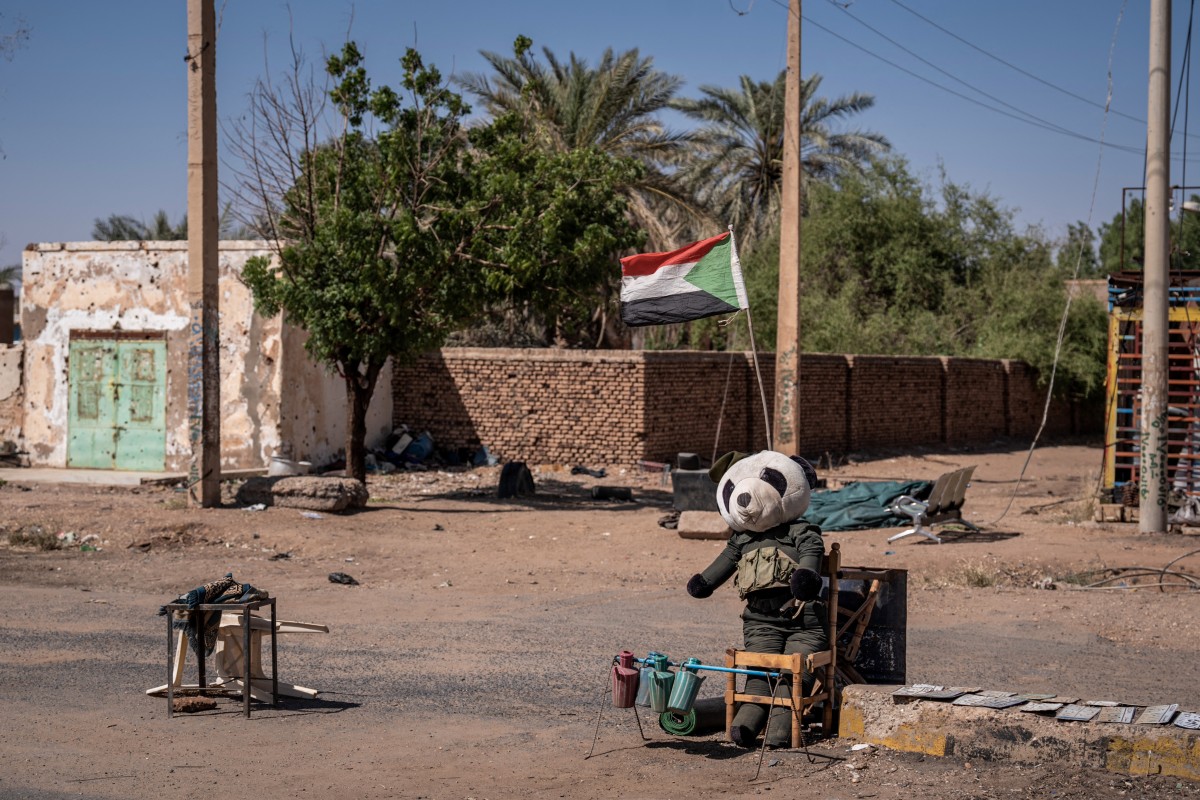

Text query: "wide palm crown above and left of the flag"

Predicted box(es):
[458, 37, 702, 247]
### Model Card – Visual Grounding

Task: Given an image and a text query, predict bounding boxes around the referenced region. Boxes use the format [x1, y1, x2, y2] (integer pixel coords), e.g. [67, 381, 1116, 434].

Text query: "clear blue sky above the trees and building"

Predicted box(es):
[0, 0, 1200, 272]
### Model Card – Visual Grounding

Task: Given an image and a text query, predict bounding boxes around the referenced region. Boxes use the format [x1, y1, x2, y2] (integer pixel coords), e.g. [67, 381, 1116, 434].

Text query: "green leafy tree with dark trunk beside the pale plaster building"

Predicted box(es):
[228, 42, 637, 480]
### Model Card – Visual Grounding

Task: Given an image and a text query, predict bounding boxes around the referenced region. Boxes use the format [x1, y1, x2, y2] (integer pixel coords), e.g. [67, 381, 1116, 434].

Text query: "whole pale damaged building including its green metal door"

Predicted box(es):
[7, 241, 391, 473]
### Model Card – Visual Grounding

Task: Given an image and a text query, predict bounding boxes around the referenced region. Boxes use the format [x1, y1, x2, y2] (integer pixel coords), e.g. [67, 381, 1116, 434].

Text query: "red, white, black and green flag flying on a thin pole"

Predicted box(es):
[620, 231, 750, 326]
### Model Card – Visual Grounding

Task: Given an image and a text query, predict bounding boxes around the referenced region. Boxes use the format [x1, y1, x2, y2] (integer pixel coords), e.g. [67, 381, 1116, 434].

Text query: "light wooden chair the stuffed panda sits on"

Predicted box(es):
[725, 542, 841, 747]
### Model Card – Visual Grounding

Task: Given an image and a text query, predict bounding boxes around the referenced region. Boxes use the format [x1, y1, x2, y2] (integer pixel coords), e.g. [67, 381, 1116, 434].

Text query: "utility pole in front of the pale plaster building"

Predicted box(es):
[186, 0, 221, 507]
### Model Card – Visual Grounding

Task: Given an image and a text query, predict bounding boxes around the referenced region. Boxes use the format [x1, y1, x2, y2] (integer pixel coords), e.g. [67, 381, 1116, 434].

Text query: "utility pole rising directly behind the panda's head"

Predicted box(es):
[773, 0, 803, 456]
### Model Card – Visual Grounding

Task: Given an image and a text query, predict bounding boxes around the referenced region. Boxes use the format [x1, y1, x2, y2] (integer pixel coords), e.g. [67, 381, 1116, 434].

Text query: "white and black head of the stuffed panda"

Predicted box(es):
[708, 450, 817, 531]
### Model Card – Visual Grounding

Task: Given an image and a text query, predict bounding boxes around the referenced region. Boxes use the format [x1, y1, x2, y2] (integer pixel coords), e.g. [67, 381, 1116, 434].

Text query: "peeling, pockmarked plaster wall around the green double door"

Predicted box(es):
[22, 241, 381, 471]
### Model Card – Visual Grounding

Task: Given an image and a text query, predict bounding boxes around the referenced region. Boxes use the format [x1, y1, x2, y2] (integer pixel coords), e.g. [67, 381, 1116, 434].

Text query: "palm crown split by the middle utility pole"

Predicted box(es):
[671, 70, 892, 247]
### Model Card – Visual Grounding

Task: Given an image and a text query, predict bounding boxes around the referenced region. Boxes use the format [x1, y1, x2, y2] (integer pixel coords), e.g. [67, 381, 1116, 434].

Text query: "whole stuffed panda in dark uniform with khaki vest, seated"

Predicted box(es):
[688, 450, 829, 747]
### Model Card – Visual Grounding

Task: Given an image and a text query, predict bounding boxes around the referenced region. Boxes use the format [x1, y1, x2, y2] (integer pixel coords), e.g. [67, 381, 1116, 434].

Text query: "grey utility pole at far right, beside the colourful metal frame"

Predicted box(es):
[1138, 0, 1171, 534]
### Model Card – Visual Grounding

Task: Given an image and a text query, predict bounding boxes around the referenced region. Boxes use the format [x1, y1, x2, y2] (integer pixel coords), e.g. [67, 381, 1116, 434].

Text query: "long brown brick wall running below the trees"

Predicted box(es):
[392, 348, 1103, 465]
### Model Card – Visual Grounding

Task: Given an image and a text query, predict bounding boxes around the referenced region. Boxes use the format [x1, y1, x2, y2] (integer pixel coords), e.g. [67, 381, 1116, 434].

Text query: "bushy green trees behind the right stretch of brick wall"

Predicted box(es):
[724, 158, 1106, 396]
